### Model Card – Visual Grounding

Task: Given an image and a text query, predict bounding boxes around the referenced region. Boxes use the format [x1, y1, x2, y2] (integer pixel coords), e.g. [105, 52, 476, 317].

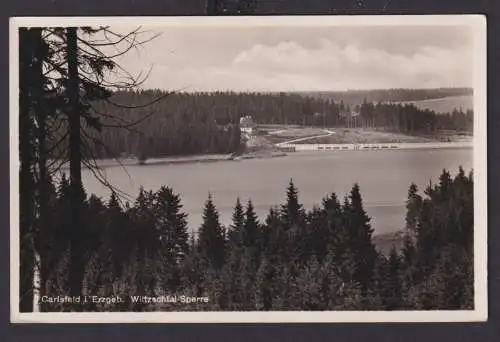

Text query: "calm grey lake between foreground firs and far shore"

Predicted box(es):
[83, 148, 473, 234]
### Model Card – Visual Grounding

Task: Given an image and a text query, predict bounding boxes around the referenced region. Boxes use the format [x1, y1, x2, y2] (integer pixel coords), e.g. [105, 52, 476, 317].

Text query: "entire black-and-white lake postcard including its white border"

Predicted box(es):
[10, 15, 487, 323]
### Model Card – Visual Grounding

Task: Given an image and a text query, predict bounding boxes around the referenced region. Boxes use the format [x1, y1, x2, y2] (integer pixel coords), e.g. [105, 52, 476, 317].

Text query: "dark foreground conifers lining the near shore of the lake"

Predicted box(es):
[36, 168, 474, 311]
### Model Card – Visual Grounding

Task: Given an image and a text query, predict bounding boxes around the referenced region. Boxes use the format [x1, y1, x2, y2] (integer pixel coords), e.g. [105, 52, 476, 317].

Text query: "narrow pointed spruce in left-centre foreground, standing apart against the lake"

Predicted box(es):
[198, 195, 226, 268]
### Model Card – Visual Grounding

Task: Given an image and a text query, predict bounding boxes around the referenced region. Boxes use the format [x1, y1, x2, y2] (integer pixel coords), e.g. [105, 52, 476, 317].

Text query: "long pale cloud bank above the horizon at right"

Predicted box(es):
[225, 39, 472, 89]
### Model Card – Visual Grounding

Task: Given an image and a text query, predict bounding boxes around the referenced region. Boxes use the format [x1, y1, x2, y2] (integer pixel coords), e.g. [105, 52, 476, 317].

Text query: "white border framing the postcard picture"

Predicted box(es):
[9, 15, 488, 323]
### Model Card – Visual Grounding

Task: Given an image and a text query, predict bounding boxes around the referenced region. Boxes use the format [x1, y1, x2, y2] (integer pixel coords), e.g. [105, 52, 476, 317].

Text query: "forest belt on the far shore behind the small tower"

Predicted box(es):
[80, 90, 473, 158]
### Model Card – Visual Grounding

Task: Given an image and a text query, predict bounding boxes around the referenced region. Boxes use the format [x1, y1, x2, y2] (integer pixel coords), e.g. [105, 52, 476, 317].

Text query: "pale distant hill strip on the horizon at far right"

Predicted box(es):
[294, 88, 473, 105]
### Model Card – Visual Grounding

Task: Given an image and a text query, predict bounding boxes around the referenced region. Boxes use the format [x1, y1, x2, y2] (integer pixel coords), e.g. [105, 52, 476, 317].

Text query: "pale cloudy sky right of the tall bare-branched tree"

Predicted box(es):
[107, 25, 473, 92]
